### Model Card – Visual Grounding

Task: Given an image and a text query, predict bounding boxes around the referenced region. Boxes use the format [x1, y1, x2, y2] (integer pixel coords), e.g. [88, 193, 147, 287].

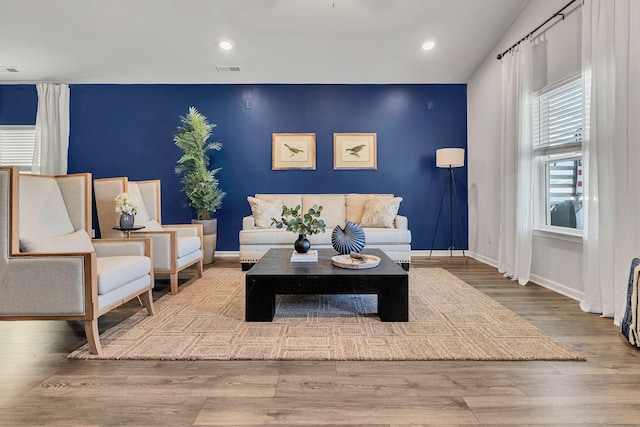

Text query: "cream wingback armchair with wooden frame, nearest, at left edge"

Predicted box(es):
[0, 166, 154, 354]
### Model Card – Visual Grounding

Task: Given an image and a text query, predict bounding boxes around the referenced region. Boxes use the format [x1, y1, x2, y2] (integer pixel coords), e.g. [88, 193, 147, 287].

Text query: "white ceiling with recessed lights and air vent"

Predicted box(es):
[0, 0, 529, 84]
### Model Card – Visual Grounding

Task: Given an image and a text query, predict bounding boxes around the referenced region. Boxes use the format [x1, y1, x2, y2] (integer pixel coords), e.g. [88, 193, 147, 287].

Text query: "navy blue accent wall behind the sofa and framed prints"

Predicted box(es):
[0, 84, 467, 251]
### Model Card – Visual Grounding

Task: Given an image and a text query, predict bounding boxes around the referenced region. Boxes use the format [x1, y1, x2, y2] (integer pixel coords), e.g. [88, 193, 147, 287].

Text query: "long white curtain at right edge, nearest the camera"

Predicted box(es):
[580, 0, 640, 325]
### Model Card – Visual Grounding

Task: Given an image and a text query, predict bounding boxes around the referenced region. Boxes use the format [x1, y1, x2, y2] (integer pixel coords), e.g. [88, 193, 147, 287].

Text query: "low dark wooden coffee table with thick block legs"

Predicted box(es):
[245, 249, 409, 322]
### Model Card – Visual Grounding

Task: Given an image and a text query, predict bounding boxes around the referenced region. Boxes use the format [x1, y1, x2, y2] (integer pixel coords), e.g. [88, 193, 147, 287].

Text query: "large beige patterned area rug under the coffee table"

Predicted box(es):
[69, 268, 584, 360]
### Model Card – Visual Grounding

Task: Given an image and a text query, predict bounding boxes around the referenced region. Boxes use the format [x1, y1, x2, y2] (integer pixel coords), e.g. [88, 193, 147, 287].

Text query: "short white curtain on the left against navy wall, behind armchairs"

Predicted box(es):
[31, 83, 69, 175]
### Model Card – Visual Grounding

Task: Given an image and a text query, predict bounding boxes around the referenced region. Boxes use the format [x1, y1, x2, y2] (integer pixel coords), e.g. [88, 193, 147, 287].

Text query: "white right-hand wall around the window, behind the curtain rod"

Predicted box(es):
[467, 0, 584, 299]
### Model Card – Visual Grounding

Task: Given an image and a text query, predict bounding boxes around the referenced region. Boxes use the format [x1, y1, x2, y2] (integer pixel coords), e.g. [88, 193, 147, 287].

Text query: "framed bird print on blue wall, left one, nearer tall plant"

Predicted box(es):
[271, 133, 316, 170]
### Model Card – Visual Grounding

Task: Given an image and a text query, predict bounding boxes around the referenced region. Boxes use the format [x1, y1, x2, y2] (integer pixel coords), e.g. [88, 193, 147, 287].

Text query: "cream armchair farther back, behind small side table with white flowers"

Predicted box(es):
[93, 177, 203, 295]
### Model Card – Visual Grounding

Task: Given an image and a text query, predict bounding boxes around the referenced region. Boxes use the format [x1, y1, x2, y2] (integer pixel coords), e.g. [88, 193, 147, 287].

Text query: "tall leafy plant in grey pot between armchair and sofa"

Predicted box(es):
[173, 107, 225, 264]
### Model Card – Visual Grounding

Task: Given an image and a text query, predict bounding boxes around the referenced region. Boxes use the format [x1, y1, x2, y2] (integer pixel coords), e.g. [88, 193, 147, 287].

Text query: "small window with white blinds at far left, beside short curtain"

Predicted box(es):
[0, 126, 36, 172]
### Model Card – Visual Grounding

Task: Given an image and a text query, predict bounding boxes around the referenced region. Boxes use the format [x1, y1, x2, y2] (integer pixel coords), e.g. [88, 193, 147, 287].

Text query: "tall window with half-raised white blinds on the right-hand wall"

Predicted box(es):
[533, 76, 584, 230]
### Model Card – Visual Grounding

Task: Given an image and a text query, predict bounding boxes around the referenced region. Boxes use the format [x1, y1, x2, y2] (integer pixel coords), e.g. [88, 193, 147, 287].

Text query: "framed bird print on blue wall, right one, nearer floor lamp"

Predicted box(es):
[333, 133, 378, 169]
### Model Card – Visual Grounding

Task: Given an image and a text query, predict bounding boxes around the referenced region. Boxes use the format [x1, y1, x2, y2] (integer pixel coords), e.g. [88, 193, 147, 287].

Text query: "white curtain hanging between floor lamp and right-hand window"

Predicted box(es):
[498, 39, 533, 285]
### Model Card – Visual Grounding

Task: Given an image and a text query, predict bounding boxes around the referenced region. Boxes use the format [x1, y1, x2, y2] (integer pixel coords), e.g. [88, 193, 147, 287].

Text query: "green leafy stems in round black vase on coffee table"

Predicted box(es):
[271, 205, 325, 253]
